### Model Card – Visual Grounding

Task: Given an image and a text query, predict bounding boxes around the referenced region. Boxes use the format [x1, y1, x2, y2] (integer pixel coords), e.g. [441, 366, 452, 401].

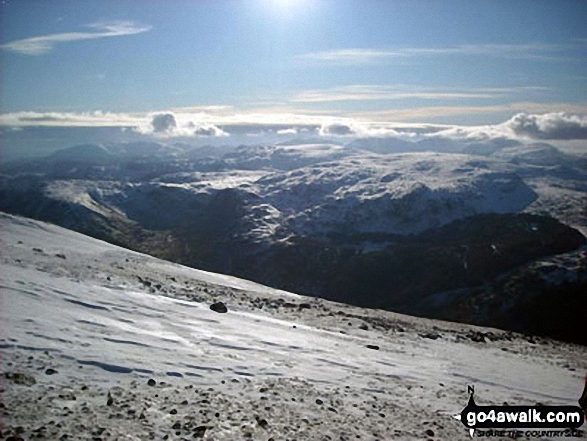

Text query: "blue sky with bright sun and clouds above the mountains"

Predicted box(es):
[0, 0, 587, 144]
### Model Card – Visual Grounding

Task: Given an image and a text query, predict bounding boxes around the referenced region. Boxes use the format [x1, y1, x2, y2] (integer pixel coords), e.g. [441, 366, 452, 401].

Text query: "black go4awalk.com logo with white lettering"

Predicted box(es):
[455, 378, 587, 438]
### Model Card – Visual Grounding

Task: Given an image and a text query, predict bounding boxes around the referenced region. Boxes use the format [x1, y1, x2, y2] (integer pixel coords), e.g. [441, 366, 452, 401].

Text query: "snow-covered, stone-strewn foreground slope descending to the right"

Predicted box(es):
[0, 214, 587, 440]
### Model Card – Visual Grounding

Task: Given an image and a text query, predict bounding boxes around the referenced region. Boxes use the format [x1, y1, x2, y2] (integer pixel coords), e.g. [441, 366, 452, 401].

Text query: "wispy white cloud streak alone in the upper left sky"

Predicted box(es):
[0, 21, 152, 55]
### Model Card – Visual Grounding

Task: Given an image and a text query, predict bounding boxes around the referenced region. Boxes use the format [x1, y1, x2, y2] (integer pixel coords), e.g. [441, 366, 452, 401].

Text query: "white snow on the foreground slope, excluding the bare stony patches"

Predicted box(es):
[0, 211, 587, 439]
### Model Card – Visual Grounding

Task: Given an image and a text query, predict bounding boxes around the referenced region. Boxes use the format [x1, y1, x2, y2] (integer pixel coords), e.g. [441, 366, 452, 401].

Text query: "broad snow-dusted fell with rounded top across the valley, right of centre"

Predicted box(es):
[256, 153, 536, 236]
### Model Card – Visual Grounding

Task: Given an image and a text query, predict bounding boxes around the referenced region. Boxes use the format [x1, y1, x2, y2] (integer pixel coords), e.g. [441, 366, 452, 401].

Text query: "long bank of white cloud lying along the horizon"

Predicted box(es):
[0, 103, 587, 140]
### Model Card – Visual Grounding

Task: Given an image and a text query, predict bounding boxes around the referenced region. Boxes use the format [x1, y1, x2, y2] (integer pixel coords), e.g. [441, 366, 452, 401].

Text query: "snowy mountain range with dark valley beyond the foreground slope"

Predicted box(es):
[0, 137, 587, 342]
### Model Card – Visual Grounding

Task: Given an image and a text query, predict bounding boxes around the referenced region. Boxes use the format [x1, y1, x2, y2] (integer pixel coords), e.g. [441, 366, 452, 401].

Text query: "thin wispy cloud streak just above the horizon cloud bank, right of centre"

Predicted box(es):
[290, 85, 545, 103]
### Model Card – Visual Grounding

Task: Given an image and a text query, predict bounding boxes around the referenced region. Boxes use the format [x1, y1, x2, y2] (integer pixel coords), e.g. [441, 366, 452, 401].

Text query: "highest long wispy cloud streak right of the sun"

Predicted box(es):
[296, 44, 565, 65]
